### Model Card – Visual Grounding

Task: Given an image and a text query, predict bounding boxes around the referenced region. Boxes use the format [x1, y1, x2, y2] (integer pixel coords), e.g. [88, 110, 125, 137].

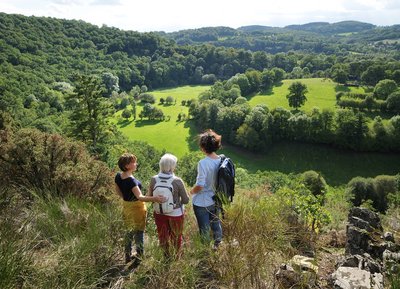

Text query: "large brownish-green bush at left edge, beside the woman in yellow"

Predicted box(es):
[0, 129, 113, 199]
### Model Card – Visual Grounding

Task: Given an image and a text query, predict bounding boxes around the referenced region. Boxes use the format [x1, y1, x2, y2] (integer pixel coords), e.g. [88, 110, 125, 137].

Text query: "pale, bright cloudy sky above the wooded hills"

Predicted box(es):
[0, 0, 400, 32]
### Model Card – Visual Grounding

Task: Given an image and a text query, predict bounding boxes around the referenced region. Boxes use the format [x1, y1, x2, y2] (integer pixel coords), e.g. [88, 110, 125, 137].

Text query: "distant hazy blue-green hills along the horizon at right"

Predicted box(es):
[167, 21, 400, 54]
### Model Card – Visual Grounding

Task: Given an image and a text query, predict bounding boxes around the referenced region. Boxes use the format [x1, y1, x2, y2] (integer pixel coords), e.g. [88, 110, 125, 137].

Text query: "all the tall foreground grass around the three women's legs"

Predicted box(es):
[0, 184, 394, 289]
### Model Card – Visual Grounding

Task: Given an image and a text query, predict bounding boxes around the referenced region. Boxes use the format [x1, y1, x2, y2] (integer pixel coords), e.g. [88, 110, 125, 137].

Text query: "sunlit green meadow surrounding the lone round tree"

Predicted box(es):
[249, 78, 364, 112]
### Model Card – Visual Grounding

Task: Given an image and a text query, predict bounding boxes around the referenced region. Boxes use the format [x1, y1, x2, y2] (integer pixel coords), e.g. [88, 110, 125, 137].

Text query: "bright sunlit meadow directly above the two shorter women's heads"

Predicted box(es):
[114, 86, 210, 156]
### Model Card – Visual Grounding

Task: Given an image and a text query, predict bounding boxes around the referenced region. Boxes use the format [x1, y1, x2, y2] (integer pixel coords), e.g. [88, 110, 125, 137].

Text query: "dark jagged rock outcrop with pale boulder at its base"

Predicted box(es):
[331, 207, 400, 289]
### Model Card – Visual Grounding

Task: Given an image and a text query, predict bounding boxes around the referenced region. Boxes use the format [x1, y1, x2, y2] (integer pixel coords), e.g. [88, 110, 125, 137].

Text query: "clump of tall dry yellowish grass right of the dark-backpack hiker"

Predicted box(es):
[211, 191, 294, 288]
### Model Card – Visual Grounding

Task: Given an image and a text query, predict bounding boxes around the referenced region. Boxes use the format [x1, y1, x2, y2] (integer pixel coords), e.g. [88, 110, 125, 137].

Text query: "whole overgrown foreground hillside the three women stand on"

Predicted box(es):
[0, 128, 399, 289]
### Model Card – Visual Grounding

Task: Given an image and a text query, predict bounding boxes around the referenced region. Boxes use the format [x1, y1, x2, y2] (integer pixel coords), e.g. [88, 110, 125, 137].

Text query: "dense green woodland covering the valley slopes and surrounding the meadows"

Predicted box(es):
[0, 13, 400, 155]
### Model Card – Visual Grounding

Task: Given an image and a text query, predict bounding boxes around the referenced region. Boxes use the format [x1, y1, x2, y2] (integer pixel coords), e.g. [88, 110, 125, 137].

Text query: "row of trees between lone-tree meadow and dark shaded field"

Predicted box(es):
[189, 71, 400, 151]
